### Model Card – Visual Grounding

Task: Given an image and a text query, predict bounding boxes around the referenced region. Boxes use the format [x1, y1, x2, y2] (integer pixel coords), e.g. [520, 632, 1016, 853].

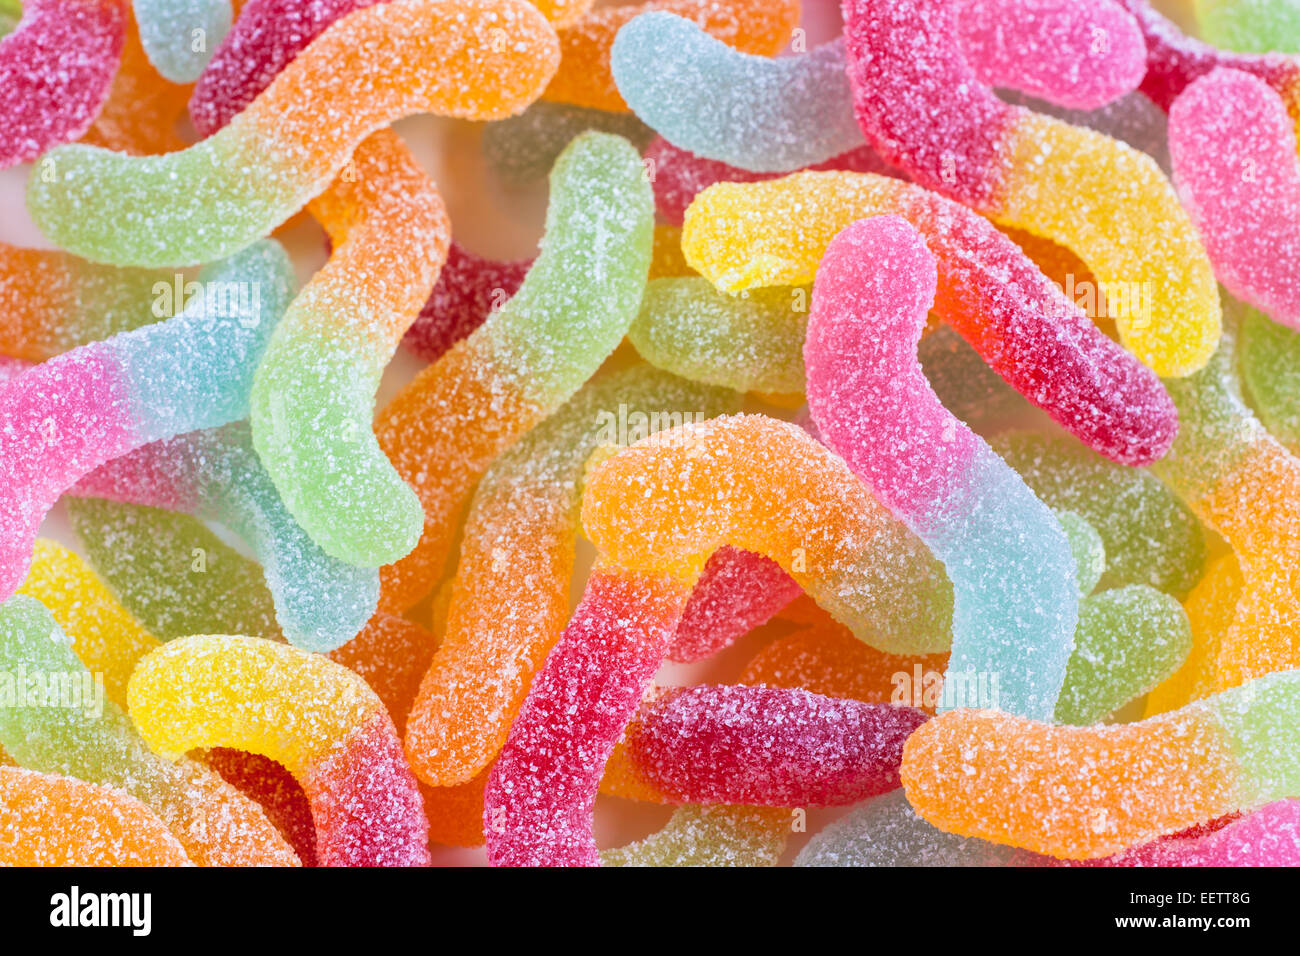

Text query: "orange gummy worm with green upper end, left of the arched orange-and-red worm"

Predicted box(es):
[406, 365, 738, 787]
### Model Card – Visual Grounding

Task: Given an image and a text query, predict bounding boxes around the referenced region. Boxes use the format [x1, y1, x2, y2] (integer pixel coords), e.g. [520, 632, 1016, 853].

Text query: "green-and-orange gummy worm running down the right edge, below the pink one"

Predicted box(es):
[1153, 299, 1300, 689]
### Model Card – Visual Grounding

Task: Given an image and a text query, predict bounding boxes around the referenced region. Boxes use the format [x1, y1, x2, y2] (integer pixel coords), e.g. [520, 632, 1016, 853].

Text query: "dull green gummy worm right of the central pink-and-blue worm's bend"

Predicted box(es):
[989, 432, 1205, 597]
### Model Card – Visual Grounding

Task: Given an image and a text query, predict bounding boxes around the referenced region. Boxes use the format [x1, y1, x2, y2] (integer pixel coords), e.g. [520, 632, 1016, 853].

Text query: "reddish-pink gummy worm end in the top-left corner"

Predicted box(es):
[0, 0, 126, 169]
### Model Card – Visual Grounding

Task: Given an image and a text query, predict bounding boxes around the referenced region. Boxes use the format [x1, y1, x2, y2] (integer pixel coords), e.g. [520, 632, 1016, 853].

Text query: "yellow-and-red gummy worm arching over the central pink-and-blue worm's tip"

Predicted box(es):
[681, 172, 1180, 464]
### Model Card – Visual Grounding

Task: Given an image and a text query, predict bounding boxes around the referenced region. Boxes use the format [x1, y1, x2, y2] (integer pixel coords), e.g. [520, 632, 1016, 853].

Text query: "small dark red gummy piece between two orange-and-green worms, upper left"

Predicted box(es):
[402, 241, 533, 363]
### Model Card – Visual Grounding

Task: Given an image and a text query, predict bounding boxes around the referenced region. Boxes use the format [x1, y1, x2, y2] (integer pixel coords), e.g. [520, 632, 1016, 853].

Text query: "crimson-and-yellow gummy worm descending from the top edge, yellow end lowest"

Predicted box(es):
[844, 0, 1221, 376]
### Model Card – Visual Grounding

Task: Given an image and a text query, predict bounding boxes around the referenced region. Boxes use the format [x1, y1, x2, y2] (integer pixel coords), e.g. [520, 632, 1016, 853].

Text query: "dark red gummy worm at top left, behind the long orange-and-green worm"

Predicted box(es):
[190, 0, 380, 137]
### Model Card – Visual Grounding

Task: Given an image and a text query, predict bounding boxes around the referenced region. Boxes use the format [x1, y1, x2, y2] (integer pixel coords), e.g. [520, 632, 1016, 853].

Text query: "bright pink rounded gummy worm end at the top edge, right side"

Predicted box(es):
[956, 0, 1147, 109]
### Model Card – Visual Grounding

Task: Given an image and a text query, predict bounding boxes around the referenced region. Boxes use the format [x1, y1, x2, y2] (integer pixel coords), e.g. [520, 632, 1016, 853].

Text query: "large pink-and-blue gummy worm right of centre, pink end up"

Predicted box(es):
[803, 216, 1078, 719]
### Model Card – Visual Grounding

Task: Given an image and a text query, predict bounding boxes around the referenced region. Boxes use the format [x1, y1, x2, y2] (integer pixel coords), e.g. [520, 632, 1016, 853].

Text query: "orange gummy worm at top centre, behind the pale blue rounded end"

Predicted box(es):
[542, 0, 800, 112]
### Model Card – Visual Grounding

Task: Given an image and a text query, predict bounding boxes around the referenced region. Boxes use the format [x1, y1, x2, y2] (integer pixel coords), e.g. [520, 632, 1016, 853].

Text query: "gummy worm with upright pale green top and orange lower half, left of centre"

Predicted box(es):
[377, 133, 654, 610]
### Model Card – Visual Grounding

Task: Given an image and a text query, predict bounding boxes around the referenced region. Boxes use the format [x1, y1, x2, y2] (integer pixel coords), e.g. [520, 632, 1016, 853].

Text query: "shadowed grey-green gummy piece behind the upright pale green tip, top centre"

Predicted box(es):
[482, 100, 654, 186]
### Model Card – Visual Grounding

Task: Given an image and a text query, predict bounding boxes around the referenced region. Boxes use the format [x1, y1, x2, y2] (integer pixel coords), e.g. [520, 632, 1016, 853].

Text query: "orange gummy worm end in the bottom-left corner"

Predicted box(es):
[0, 766, 194, 866]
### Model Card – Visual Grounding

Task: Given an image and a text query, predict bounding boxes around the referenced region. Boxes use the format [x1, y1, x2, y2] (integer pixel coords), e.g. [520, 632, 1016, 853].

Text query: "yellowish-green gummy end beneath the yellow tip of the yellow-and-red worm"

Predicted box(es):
[628, 276, 811, 394]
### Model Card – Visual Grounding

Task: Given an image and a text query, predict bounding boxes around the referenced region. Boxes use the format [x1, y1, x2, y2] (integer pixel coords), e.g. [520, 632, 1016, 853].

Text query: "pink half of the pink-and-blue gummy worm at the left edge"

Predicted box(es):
[0, 342, 139, 600]
